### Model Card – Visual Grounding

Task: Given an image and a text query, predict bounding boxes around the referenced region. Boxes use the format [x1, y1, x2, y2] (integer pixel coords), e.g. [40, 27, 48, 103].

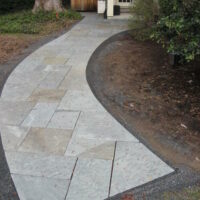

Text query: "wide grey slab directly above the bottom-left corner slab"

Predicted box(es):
[6, 152, 76, 179]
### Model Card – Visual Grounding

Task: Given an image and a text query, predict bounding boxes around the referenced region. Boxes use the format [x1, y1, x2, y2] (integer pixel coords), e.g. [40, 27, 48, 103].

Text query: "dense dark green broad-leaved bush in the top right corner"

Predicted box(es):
[152, 0, 200, 62]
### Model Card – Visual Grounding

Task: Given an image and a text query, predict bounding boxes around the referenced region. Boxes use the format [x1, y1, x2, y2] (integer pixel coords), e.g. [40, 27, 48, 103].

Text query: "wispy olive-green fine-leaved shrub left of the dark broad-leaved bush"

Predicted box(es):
[129, 0, 159, 40]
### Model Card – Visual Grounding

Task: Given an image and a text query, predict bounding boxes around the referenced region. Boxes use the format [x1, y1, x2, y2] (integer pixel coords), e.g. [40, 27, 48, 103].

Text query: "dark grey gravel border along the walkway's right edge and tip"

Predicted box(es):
[86, 31, 200, 200]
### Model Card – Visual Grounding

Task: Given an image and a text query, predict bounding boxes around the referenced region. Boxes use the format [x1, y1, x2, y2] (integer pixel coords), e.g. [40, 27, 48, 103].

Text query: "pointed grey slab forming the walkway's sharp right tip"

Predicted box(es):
[110, 142, 173, 196]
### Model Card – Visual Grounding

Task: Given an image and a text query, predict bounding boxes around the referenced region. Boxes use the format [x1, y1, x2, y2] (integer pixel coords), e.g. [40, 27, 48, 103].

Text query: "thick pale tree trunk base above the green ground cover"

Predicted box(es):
[33, 0, 63, 12]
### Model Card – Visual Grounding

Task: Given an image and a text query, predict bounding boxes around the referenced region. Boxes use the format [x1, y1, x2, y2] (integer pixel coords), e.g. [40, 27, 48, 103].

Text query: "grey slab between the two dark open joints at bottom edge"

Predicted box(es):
[66, 159, 112, 200]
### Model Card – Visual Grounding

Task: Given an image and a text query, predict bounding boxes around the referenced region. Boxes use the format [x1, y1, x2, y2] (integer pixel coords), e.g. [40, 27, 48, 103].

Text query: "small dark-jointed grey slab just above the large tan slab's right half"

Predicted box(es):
[48, 110, 79, 130]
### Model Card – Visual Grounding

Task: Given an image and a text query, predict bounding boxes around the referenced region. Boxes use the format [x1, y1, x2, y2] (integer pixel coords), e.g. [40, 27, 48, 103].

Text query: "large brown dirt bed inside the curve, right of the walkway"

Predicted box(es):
[99, 35, 200, 170]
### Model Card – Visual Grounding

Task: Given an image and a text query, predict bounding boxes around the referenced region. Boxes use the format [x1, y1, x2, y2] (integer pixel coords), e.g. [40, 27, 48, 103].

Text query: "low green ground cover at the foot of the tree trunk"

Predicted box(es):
[0, 10, 81, 34]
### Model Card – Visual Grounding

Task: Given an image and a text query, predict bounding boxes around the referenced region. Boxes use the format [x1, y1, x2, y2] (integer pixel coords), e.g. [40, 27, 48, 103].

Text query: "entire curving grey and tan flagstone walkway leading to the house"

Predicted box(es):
[0, 13, 173, 200]
